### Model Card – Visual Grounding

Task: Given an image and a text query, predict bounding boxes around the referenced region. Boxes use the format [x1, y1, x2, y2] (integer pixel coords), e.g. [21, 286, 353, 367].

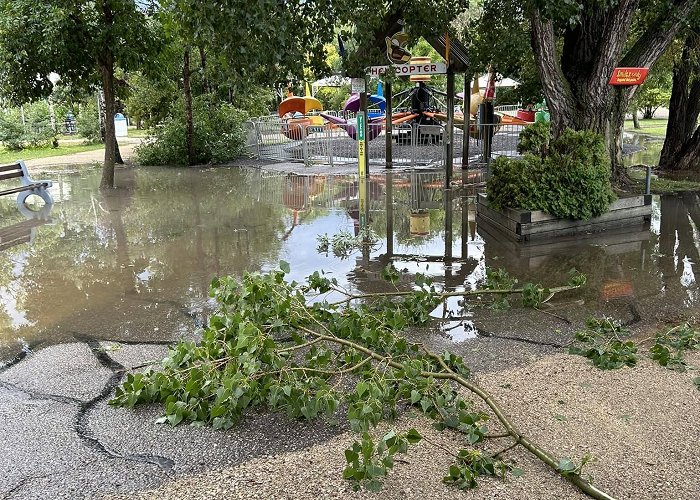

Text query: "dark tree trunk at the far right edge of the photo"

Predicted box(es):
[659, 33, 700, 170]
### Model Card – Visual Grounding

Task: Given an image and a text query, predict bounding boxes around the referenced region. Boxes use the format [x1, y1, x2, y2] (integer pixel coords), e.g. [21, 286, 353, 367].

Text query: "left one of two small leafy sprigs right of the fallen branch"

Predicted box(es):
[569, 318, 637, 370]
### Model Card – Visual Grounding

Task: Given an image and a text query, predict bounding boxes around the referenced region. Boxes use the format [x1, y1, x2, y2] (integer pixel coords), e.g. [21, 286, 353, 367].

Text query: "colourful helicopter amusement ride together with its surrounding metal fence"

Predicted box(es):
[248, 34, 528, 172]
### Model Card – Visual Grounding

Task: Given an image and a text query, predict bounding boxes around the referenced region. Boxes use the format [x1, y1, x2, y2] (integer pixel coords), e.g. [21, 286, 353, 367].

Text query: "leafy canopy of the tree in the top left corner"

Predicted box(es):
[0, 0, 157, 104]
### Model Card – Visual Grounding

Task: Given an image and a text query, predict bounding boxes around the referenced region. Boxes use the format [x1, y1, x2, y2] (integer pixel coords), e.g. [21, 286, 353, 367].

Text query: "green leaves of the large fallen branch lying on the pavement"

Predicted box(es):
[110, 263, 556, 490]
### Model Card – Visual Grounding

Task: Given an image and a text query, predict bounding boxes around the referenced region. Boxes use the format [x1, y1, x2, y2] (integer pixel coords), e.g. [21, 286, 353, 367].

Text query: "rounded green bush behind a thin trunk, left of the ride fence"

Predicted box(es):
[136, 98, 248, 165]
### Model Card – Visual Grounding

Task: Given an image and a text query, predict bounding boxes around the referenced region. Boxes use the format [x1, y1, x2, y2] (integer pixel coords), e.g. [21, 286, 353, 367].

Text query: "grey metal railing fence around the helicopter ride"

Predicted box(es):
[246, 117, 524, 168]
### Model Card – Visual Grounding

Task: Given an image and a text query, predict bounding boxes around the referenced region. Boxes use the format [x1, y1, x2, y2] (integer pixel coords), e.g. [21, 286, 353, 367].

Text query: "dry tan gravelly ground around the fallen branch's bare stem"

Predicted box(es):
[126, 353, 700, 500]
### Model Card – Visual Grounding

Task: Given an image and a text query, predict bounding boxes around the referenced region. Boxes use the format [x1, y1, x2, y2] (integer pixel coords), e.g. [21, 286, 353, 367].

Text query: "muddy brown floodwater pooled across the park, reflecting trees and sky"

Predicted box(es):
[0, 167, 700, 361]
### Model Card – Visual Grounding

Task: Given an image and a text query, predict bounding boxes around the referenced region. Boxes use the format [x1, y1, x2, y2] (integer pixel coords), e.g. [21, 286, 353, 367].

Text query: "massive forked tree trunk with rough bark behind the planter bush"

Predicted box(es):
[531, 0, 697, 183]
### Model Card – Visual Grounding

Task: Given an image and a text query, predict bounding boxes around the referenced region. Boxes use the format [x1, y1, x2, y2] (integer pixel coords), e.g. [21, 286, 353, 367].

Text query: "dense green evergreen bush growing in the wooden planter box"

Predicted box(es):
[487, 129, 615, 219]
